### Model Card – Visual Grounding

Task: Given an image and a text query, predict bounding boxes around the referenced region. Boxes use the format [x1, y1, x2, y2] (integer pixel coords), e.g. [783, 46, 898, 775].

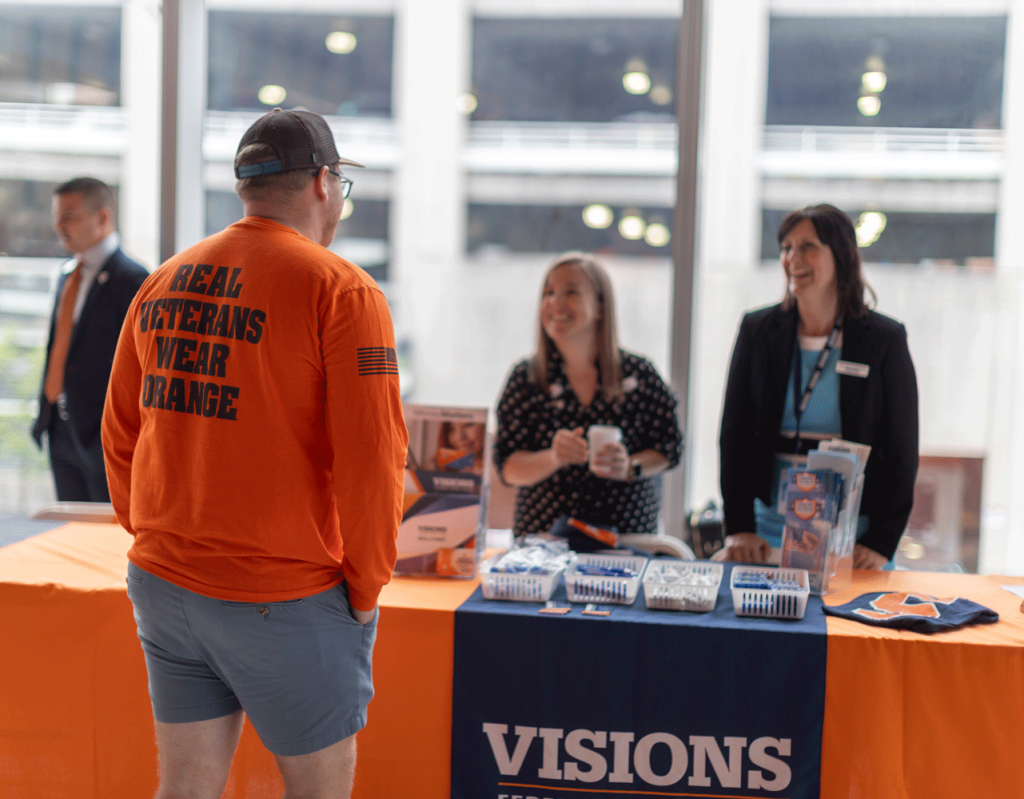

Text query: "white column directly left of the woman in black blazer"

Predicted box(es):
[687, 0, 781, 512]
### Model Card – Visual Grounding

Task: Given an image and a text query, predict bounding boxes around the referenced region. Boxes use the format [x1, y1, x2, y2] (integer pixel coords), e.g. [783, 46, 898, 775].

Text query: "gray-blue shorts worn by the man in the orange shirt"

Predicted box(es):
[128, 562, 378, 756]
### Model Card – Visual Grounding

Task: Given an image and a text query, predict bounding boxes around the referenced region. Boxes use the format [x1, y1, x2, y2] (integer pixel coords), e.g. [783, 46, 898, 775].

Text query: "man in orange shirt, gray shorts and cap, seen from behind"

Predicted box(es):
[102, 110, 408, 797]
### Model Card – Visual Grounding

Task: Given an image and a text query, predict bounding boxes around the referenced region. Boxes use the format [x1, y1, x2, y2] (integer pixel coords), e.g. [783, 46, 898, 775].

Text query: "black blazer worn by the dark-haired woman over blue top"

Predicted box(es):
[719, 305, 918, 558]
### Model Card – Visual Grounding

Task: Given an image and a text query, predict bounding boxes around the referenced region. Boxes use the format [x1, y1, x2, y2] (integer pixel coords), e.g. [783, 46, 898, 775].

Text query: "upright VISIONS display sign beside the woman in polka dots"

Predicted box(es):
[395, 405, 490, 577]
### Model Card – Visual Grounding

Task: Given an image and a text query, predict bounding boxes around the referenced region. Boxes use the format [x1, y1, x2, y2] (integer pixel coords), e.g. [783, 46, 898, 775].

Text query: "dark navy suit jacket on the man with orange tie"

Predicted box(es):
[32, 248, 150, 449]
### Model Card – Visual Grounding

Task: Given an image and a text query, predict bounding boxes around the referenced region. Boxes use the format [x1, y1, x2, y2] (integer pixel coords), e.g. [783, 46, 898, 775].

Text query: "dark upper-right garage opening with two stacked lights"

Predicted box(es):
[766, 16, 1007, 128]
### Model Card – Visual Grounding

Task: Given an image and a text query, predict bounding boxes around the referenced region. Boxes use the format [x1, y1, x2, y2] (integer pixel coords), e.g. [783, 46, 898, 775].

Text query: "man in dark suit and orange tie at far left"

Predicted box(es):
[32, 177, 148, 502]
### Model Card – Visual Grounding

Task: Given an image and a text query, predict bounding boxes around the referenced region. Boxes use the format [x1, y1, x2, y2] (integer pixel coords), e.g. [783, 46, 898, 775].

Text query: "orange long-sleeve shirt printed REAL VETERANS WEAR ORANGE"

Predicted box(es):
[102, 217, 408, 611]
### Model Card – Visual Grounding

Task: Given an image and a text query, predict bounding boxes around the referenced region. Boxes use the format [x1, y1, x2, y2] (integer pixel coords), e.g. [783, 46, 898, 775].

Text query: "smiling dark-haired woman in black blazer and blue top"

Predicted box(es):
[716, 205, 918, 569]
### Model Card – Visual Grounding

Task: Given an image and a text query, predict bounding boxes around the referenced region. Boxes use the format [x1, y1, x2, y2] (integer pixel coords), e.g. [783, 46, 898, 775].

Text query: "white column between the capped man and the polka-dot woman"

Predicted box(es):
[391, 0, 478, 403]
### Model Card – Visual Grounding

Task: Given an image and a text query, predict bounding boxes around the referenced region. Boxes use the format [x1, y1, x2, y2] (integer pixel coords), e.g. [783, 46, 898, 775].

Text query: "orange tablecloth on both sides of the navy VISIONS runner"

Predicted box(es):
[0, 523, 1024, 799]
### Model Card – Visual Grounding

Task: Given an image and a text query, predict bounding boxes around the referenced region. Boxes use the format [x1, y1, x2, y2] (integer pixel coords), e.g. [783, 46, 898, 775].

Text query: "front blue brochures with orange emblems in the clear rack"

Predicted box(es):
[780, 469, 845, 593]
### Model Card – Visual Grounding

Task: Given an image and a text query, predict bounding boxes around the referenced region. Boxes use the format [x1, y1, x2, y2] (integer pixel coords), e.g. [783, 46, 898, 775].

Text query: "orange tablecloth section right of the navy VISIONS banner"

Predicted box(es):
[821, 572, 1024, 799]
